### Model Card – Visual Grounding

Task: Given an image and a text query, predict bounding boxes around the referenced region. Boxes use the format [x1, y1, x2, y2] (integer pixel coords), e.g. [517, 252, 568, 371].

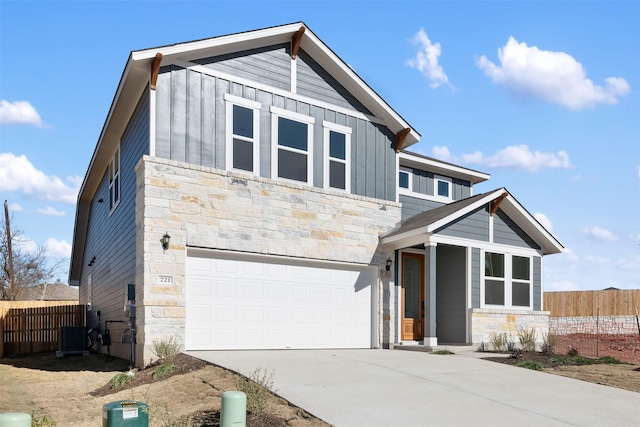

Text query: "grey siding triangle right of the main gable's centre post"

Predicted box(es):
[296, 49, 370, 114]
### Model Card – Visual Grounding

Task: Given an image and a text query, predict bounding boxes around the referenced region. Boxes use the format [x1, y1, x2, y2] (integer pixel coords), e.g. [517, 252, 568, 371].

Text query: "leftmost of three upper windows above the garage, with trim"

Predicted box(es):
[224, 94, 261, 175]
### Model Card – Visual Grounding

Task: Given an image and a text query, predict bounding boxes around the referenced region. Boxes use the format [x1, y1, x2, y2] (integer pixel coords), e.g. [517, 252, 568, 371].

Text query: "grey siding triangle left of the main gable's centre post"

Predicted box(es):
[193, 43, 291, 90]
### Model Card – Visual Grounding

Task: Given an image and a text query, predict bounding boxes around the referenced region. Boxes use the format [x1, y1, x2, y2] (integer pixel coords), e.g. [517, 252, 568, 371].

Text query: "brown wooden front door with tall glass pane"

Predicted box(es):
[401, 253, 424, 341]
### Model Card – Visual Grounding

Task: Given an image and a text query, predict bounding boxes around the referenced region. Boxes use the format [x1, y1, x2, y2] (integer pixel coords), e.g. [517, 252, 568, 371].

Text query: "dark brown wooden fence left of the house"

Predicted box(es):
[0, 302, 86, 357]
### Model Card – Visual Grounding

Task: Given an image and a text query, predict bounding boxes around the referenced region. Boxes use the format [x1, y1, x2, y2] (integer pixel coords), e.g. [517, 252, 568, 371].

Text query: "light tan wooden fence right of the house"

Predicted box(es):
[544, 289, 640, 317]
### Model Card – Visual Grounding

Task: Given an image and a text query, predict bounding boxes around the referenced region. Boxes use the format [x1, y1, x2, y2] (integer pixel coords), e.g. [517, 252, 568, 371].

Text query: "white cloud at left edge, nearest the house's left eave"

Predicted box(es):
[0, 153, 82, 204]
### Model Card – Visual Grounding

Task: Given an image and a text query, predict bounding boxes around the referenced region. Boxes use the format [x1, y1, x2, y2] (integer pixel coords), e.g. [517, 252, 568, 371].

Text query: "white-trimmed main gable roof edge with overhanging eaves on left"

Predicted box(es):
[69, 22, 420, 284]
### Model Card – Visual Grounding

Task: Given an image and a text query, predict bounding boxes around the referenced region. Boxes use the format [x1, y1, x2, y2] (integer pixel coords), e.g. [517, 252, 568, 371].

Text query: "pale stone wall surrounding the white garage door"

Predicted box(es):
[136, 156, 401, 364]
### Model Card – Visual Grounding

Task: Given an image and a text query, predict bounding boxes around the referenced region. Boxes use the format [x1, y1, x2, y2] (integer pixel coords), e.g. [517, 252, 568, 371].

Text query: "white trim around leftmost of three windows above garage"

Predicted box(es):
[224, 93, 262, 176]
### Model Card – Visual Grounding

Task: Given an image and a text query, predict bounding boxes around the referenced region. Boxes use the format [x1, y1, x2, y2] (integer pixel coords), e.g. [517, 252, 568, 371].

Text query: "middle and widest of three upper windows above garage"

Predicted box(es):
[271, 107, 315, 184]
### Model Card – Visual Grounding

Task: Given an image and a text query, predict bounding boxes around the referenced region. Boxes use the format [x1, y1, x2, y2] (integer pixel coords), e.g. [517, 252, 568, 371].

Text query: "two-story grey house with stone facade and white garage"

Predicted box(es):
[69, 23, 562, 365]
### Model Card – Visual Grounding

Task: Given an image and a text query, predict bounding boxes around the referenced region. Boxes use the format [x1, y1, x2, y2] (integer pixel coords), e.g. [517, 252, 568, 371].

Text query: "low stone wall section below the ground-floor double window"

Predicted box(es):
[471, 308, 550, 350]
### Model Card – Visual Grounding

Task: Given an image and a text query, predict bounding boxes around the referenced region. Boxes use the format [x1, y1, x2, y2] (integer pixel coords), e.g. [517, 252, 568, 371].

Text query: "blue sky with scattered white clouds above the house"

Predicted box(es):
[0, 0, 640, 290]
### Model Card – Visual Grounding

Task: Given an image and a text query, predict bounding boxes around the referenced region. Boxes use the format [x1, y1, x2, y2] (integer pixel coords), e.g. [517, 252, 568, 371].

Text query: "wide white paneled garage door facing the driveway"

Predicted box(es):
[185, 254, 375, 350]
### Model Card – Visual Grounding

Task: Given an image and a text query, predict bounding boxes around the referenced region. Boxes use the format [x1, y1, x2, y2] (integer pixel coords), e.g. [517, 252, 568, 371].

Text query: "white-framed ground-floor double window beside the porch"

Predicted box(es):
[484, 252, 531, 308]
